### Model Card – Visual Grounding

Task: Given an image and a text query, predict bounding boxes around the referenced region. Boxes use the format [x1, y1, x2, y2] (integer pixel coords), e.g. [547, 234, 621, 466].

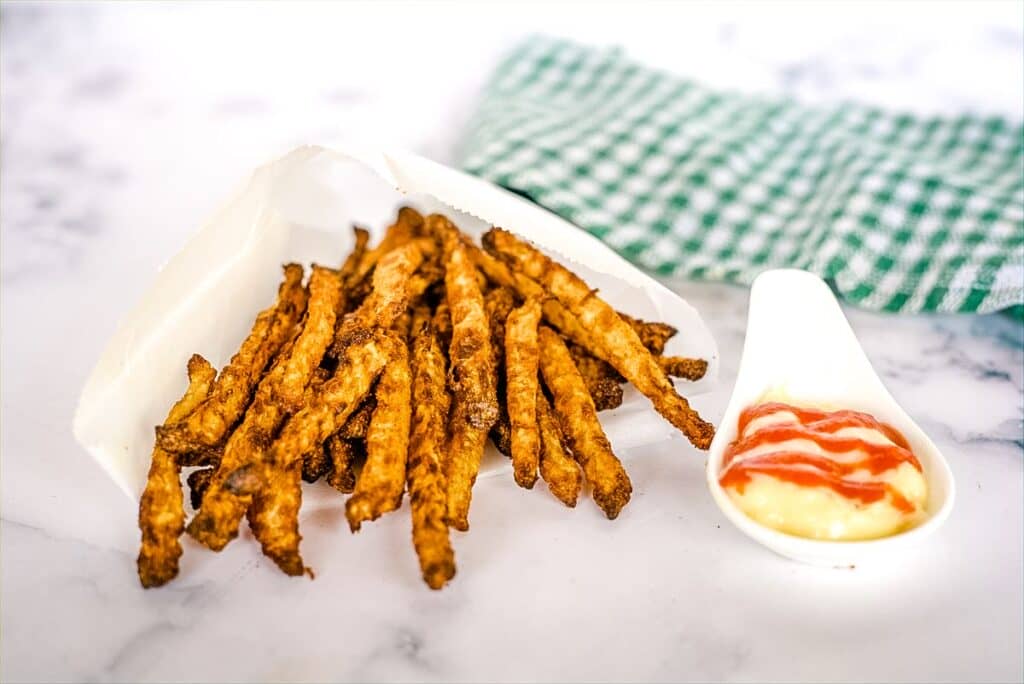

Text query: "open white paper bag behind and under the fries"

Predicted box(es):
[74, 146, 718, 507]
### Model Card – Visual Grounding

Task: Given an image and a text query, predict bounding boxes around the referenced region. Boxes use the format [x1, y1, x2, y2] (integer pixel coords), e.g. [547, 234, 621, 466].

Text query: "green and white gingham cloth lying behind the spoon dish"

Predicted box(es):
[462, 38, 1024, 314]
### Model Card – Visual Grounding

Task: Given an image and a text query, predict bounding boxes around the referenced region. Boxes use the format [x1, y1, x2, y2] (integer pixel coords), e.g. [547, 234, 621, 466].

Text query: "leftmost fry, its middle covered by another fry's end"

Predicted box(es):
[137, 354, 217, 589]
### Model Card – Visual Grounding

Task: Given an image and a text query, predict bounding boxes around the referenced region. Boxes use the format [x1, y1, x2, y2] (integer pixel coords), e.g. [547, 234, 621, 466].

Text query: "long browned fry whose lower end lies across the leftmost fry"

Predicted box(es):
[157, 264, 306, 453]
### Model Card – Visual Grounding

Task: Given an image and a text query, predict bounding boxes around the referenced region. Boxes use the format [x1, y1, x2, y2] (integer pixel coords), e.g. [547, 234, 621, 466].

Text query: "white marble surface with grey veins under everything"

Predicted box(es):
[0, 3, 1024, 681]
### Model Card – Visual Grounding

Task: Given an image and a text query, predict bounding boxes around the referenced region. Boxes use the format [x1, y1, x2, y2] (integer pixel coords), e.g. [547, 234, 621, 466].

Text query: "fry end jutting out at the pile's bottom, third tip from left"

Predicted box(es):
[247, 460, 306, 576]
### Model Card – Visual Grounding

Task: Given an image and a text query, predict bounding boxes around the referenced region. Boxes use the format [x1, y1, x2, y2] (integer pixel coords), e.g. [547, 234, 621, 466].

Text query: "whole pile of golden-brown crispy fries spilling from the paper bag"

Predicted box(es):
[138, 208, 714, 589]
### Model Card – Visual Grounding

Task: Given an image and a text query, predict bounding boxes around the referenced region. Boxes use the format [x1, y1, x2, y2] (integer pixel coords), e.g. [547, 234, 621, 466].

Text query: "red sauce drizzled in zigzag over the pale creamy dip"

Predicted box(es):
[719, 401, 922, 513]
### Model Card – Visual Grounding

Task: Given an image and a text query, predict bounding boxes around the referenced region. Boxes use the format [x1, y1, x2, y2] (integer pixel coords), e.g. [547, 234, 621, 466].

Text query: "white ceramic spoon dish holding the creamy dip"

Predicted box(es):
[708, 269, 954, 567]
